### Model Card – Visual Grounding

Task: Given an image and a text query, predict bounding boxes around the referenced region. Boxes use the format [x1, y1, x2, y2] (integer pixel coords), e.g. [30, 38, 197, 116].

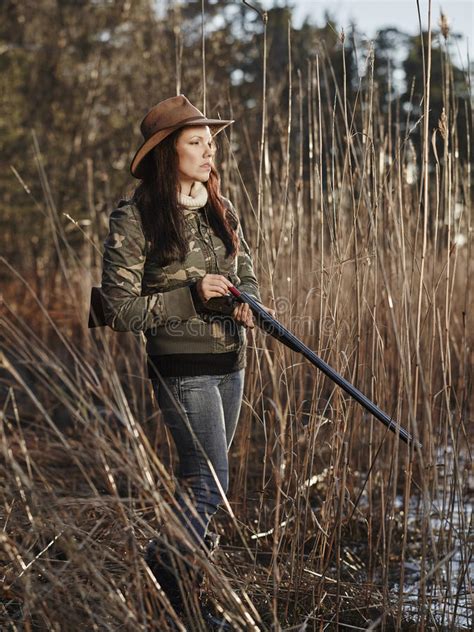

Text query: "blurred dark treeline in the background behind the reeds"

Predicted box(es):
[0, 0, 470, 266]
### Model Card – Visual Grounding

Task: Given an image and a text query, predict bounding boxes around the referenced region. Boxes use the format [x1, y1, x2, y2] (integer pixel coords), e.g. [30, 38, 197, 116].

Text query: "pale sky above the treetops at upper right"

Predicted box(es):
[262, 0, 474, 60]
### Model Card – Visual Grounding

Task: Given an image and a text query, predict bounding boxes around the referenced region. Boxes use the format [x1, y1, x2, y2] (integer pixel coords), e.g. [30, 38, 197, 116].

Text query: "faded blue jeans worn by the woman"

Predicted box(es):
[152, 369, 245, 544]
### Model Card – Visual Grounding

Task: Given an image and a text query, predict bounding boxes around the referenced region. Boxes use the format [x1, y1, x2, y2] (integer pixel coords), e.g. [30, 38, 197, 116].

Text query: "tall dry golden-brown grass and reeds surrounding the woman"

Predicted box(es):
[0, 4, 473, 631]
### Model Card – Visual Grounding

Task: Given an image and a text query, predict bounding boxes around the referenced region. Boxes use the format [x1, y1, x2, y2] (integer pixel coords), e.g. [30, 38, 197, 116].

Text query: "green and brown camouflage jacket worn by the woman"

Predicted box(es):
[102, 199, 261, 355]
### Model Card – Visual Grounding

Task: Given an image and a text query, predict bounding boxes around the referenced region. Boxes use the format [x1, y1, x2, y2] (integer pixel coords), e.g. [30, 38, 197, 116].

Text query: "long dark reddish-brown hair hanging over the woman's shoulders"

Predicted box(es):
[134, 128, 239, 266]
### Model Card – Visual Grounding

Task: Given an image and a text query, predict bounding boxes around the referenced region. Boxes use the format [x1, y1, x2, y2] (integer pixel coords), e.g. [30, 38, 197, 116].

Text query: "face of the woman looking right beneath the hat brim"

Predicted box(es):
[176, 125, 215, 195]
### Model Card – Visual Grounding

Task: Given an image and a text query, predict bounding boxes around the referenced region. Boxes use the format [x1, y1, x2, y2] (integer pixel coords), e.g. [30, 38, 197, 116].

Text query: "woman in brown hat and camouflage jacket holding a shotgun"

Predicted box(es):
[102, 95, 266, 624]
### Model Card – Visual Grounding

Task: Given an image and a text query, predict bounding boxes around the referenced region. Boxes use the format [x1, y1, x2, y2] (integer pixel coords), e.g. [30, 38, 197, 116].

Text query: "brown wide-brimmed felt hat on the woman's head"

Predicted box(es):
[130, 94, 234, 178]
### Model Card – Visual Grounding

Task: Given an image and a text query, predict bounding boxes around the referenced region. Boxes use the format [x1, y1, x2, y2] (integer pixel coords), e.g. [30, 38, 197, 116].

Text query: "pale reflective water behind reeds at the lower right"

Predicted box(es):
[391, 451, 474, 630]
